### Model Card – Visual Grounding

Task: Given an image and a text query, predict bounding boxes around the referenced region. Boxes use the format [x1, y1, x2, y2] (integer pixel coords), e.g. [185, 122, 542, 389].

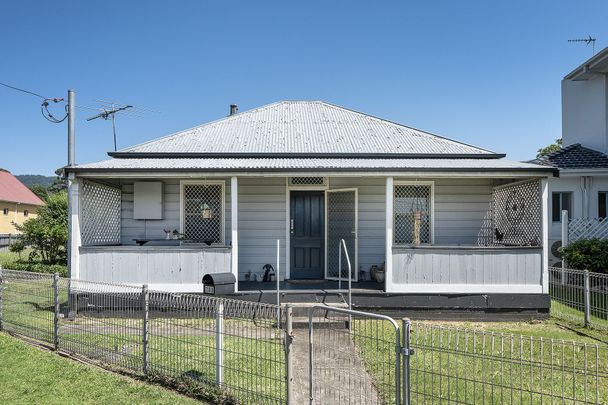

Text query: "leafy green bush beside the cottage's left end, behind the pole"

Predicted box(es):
[14, 191, 68, 264]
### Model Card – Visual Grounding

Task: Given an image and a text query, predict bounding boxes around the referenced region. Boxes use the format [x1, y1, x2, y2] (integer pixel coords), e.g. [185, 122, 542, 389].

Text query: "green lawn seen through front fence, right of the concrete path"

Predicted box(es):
[353, 320, 608, 404]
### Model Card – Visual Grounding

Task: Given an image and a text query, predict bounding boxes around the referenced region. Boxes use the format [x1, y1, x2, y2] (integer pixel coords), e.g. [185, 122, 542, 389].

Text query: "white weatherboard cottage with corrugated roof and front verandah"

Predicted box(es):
[66, 101, 554, 304]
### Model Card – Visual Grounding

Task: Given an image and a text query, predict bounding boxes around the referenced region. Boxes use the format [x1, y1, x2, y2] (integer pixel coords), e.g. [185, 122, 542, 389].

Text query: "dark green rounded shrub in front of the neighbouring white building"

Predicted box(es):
[561, 239, 608, 273]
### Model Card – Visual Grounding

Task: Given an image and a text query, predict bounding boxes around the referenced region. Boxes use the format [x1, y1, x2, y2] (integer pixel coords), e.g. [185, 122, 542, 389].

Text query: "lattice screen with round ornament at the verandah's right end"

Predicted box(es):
[492, 180, 542, 246]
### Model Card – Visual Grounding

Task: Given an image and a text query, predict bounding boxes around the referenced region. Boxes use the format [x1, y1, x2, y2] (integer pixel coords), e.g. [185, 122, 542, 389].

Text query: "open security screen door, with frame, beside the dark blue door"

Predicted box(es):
[325, 188, 359, 281]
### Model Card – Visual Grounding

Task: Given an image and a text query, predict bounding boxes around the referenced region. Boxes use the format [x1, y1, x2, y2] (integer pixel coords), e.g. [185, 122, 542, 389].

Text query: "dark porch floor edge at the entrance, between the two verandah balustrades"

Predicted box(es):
[239, 280, 384, 292]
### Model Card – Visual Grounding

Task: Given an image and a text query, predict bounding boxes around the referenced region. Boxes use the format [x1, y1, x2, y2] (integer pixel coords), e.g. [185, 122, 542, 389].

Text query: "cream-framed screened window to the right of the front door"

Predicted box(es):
[393, 184, 433, 245]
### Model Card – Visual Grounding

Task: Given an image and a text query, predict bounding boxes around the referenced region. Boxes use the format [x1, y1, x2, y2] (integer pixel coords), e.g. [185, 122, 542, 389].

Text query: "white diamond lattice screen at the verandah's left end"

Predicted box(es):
[80, 180, 121, 245]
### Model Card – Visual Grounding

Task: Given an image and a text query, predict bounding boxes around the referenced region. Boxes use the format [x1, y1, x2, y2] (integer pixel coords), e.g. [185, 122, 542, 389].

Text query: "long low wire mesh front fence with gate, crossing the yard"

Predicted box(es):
[0, 269, 608, 404]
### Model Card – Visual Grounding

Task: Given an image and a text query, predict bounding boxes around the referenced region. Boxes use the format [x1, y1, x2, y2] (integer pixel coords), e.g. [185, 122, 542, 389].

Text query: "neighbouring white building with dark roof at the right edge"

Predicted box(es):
[535, 48, 608, 265]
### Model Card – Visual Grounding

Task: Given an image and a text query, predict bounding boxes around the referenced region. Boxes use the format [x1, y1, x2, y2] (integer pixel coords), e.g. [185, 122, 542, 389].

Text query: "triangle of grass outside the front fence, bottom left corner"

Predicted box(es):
[0, 333, 200, 404]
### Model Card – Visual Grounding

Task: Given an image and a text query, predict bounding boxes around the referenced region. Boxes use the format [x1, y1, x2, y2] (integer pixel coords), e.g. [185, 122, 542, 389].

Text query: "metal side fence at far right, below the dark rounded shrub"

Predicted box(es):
[549, 267, 608, 329]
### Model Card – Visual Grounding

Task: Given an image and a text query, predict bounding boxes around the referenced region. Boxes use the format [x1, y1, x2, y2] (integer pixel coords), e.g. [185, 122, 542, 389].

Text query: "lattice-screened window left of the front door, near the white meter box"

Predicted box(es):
[182, 183, 224, 245]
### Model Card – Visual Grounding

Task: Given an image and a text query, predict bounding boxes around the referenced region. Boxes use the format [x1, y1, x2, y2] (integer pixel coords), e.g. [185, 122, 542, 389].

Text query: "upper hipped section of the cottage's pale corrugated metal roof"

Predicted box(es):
[112, 101, 494, 156]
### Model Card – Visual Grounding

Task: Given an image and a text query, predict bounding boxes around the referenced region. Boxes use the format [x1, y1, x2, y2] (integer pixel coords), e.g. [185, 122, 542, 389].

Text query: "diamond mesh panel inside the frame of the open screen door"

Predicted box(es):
[327, 191, 357, 279]
